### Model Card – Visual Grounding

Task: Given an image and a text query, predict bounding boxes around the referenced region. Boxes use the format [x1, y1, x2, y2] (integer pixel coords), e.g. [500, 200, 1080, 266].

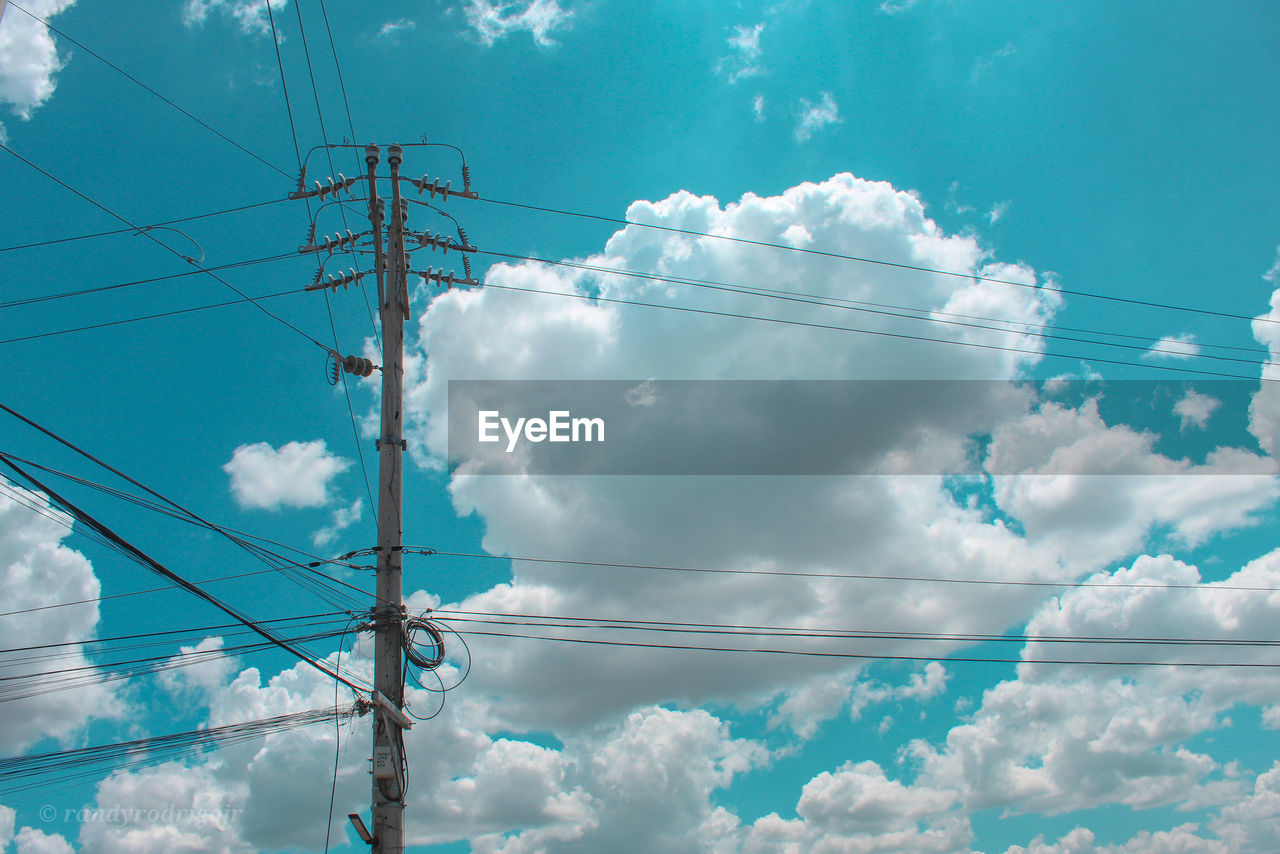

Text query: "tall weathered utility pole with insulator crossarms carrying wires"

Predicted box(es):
[296, 140, 480, 854]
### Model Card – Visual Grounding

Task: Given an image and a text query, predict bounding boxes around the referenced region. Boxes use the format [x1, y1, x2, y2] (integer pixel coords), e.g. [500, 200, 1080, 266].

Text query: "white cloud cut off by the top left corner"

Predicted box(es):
[0, 0, 74, 126]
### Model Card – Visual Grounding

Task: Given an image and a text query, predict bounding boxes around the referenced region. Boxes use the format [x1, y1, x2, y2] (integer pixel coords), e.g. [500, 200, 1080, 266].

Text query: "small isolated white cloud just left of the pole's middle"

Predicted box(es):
[223, 439, 351, 510]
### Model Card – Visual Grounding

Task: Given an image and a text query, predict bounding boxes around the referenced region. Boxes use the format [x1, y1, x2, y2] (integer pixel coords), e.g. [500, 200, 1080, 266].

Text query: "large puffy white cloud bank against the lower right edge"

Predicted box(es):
[913, 552, 1280, 816]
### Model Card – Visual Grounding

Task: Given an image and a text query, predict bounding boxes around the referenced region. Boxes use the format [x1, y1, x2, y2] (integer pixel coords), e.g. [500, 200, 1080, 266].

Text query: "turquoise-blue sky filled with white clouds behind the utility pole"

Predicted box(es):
[0, 0, 1280, 854]
